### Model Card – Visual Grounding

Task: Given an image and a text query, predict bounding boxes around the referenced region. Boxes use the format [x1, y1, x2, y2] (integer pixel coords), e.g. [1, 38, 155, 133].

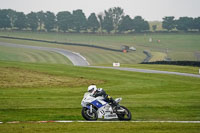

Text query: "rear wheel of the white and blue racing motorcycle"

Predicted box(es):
[117, 106, 132, 121]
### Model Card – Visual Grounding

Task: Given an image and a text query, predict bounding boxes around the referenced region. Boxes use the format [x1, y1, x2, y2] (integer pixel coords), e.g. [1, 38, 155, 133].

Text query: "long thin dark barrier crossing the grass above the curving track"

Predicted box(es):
[0, 36, 122, 52]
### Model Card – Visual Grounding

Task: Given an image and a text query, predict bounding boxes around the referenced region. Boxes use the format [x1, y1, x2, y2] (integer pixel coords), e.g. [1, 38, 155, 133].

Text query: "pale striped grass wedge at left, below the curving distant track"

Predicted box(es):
[0, 45, 72, 65]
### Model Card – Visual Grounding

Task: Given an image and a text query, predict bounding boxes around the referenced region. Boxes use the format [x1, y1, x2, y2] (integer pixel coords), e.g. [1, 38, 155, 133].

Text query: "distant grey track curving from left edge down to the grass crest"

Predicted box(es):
[0, 42, 89, 66]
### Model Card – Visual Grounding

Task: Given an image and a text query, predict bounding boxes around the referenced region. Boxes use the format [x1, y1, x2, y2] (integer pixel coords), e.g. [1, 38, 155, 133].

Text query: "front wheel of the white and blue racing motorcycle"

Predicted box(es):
[82, 107, 98, 121]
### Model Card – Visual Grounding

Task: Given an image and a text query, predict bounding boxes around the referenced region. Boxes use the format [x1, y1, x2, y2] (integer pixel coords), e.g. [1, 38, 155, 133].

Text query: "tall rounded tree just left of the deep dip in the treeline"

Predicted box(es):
[72, 9, 87, 32]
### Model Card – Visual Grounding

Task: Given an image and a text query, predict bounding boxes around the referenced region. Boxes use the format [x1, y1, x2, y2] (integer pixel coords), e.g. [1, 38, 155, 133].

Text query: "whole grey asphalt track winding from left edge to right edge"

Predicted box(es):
[0, 42, 200, 78]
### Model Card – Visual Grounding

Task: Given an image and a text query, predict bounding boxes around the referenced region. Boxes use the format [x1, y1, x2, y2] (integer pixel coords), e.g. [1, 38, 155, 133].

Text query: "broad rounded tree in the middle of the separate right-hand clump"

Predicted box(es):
[176, 17, 194, 31]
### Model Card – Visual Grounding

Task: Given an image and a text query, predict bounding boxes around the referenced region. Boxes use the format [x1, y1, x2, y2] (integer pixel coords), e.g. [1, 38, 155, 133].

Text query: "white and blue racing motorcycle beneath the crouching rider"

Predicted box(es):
[81, 92, 131, 121]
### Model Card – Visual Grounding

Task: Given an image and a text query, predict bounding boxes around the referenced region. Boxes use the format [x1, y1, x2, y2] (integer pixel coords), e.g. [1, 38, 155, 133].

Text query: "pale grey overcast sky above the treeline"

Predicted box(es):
[0, 0, 200, 21]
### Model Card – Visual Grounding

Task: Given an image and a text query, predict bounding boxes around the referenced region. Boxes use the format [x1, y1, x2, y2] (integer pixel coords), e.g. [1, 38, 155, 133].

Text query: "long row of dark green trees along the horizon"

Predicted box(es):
[0, 7, 200, 33]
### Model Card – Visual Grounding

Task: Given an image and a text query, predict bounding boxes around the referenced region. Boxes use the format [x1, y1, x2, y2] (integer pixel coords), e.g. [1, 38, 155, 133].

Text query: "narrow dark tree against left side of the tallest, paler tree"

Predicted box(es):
[102, 11, 114, 33]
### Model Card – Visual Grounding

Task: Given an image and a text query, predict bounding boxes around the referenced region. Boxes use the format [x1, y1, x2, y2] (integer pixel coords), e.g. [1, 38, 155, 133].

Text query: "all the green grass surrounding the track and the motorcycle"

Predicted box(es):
[0, 32, 200, 133]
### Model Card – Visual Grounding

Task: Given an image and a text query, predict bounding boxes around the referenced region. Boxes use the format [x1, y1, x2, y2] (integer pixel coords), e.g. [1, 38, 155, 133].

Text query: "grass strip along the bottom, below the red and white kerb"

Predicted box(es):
[0, 123, 200, 133]
